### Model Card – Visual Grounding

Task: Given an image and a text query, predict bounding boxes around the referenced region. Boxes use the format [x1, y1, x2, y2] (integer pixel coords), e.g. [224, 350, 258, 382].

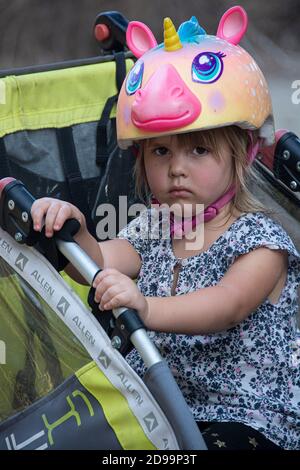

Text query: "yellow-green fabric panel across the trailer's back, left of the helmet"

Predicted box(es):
[0, 59, 133, 137]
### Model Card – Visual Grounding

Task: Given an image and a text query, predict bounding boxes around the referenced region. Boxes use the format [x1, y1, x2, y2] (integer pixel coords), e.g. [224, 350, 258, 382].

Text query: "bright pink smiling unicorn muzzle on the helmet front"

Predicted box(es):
[131, 64, 201, 132]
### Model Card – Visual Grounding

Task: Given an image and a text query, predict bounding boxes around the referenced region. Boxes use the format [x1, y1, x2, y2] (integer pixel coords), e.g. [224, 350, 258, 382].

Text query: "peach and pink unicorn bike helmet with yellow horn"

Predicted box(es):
[117, 6, 274, 149]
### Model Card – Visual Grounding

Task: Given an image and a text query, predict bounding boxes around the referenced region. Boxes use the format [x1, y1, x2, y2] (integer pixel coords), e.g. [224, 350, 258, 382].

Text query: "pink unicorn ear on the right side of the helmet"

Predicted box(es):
[216, 6, 248, 44]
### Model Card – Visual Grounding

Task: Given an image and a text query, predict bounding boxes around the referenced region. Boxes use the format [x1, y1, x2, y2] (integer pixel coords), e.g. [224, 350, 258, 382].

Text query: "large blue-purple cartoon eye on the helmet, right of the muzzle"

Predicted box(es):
[192, 52, 225, 83]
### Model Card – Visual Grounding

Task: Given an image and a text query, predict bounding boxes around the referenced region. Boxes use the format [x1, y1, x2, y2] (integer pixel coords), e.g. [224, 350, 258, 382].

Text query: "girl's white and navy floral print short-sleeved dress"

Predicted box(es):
[118, 209, 300, 449]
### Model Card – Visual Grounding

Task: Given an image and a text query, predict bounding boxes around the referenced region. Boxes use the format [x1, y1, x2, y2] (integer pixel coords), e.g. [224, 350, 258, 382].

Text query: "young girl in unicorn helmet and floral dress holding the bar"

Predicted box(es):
[32, 7, 300, 449]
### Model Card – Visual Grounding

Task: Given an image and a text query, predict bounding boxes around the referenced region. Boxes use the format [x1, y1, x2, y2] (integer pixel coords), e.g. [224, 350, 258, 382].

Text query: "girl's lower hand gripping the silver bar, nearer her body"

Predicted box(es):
[93, 269, 148, 320]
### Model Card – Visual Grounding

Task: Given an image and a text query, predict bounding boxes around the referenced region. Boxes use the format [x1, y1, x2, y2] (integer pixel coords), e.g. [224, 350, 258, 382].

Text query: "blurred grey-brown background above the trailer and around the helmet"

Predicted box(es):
[0, 0, 300, 134]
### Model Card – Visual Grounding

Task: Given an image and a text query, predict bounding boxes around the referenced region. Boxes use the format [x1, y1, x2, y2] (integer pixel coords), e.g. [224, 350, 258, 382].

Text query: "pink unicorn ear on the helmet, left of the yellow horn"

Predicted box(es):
[126, 21, 157, 59]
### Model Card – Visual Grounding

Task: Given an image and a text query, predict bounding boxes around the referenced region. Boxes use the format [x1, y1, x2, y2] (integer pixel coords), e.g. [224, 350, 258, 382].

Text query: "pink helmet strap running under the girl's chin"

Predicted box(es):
[152, 131, 260, 237]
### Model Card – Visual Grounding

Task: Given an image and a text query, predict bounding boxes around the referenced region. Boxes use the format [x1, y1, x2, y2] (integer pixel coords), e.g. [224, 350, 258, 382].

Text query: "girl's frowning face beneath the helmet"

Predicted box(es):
[144, 132, 233, 212]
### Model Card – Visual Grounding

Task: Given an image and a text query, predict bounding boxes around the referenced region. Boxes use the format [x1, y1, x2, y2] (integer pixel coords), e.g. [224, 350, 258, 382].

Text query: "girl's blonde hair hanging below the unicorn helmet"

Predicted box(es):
[134, 126, 268, 217]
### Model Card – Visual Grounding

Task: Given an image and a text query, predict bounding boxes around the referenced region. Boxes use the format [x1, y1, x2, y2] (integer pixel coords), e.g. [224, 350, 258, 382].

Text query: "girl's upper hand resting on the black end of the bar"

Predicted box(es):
[31, 197, 86, 238]
